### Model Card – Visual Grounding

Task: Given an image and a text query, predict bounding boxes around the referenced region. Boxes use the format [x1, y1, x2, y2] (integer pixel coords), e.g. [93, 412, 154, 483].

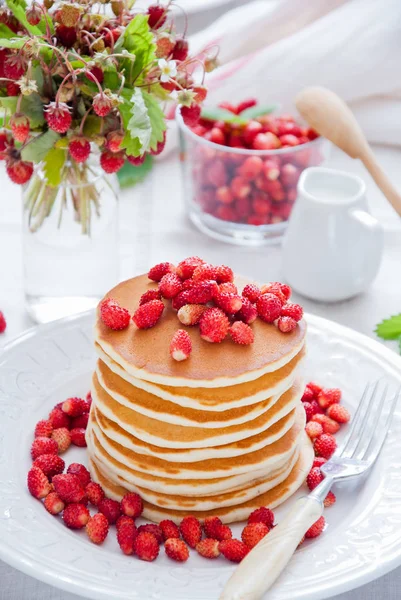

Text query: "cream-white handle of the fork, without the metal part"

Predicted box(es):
[220, 496, 323, 600]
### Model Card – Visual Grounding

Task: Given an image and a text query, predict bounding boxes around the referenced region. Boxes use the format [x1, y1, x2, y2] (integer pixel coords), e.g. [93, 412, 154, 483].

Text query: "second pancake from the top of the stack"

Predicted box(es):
[95, 344, 306, 411]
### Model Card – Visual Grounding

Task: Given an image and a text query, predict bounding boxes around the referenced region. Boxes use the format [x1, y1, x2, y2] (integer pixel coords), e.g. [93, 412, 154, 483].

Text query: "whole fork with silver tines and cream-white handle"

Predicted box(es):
[220, 381, 401, 600]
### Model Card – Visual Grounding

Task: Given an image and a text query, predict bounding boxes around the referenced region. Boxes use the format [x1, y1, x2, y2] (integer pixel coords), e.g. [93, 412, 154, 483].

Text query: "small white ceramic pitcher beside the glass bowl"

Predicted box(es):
[283, 167, 383, 302]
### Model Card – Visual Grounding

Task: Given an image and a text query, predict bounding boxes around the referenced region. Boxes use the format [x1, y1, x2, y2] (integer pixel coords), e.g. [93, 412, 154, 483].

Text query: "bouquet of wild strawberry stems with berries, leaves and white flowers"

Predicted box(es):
[0, 0, 206, 233]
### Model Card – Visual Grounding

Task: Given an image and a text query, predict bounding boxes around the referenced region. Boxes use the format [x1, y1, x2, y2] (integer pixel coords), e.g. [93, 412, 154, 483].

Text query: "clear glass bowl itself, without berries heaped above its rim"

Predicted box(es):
[176, 107, 330, 246]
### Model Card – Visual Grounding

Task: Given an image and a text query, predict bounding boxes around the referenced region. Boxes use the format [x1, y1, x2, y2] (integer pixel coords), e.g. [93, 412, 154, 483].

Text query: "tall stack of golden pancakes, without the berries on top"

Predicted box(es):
[87, 275, 313, 522]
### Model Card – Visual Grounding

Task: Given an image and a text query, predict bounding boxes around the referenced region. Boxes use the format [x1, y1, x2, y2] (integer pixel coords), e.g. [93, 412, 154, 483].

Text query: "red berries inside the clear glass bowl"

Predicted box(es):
[192, 100, 323, 225]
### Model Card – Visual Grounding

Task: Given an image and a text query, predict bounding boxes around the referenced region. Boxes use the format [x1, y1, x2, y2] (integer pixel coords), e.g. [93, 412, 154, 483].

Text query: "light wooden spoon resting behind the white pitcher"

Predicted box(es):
[295, 86, 401, 216]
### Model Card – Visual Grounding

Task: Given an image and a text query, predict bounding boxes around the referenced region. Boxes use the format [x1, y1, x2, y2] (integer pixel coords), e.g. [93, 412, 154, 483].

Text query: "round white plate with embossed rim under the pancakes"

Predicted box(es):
[0, 314, 401, 600]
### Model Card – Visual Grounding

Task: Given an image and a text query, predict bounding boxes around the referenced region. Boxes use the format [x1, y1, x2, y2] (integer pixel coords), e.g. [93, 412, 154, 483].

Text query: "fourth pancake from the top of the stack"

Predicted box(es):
[92, 373, 303, 448]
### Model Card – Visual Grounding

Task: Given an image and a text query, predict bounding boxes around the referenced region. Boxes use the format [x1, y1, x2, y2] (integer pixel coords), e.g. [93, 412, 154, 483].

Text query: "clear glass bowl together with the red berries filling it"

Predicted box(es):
[176, 99, 330, 246]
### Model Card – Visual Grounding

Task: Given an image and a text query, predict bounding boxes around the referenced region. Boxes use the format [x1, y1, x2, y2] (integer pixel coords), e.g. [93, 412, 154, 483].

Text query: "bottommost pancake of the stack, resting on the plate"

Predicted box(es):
[89, 433, 314, 523]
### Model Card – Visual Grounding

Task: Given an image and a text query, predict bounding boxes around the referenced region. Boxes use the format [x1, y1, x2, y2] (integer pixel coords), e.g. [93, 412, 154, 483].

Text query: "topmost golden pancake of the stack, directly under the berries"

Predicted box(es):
[95, 275, 306, 388]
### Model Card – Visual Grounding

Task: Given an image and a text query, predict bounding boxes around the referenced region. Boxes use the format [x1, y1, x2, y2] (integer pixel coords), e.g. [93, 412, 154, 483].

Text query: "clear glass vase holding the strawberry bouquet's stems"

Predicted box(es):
[23, 157, 119, 323]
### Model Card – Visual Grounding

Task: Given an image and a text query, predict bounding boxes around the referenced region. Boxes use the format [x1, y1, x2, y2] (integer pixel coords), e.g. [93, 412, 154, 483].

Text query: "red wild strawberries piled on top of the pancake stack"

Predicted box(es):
[100, 256, 303, 361]
